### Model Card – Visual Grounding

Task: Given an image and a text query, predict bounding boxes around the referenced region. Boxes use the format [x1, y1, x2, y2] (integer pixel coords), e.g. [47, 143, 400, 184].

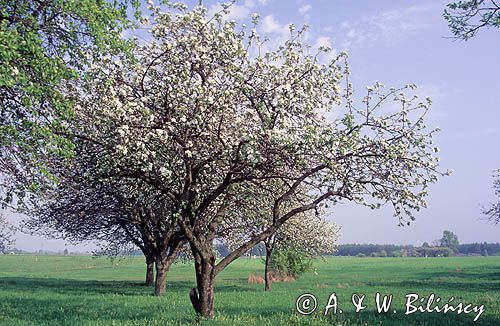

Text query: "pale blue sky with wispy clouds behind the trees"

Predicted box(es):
[4, 0, 500, 251]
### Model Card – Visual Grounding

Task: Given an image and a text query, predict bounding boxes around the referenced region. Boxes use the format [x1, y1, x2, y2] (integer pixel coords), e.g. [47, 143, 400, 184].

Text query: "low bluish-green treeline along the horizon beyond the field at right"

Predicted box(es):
[335, 242, 500, 257]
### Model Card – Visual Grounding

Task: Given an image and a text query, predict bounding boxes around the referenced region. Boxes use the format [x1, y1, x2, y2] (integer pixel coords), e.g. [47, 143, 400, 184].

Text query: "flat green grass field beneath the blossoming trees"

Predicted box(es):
[0, 255, 500, 325]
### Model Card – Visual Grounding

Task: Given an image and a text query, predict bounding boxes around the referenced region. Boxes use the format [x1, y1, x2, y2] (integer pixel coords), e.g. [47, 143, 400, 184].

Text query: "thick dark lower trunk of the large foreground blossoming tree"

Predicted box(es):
[189, 255, 215, 318]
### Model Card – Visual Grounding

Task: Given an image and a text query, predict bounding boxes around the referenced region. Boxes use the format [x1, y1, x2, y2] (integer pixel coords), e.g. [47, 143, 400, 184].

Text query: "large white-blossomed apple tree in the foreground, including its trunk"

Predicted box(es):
[65, 1, 446, 317]
